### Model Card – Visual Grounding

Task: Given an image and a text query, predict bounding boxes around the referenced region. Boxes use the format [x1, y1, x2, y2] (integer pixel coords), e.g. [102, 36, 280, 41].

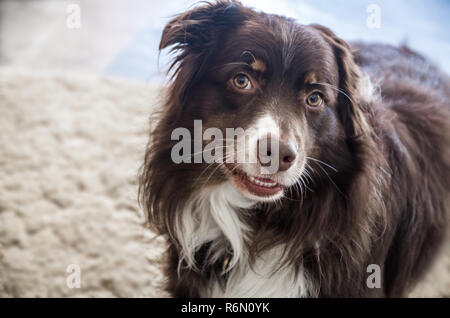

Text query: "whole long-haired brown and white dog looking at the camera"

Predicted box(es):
[140, 1, 450, 297]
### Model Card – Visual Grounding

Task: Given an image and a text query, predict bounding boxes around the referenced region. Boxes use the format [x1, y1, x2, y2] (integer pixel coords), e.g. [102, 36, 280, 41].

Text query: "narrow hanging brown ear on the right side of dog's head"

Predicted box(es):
[310, 24, 369, 137]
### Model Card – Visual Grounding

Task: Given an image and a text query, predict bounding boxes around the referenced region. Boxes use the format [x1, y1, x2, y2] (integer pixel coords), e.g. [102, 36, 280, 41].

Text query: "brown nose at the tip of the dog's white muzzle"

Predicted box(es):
[257, 136, 297, 172]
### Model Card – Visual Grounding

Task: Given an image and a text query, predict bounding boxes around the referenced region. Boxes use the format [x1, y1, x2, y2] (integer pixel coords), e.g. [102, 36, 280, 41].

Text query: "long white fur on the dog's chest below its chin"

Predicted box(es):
[176, 182, 312, 297]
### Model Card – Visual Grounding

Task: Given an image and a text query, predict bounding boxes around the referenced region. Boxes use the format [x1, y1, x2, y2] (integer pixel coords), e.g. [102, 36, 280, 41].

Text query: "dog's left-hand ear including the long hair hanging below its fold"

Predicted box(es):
[159, 0, 249, 105]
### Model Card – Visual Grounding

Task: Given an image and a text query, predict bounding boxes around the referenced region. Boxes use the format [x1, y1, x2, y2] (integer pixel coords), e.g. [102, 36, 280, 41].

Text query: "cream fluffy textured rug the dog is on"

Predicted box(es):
[0, 69, 450, 297]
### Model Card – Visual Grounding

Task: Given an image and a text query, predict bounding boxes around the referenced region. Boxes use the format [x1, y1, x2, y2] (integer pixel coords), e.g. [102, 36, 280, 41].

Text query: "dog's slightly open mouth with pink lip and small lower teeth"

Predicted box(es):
[227, 166, 284, 200]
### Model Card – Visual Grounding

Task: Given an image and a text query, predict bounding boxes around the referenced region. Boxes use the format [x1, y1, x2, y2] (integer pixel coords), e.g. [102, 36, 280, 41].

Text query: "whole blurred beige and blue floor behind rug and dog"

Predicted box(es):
[0, 0, 450, 83]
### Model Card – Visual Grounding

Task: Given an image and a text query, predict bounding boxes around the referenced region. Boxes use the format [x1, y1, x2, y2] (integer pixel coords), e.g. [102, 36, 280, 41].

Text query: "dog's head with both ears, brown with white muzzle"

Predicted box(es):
[161, 1, 359, 201]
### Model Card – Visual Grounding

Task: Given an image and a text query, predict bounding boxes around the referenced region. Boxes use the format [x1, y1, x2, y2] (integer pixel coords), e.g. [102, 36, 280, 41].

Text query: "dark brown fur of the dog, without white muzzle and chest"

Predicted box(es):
[140, 1, 450, 297]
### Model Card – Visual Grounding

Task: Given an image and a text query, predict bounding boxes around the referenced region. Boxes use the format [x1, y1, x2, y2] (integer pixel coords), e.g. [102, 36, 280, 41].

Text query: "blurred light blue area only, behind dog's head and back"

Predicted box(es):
[106, 0, 450, 82]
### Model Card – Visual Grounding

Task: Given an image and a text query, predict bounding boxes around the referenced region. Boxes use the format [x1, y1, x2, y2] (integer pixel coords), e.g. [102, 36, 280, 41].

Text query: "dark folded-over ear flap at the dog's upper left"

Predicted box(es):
[159, 0, 243, 51]
